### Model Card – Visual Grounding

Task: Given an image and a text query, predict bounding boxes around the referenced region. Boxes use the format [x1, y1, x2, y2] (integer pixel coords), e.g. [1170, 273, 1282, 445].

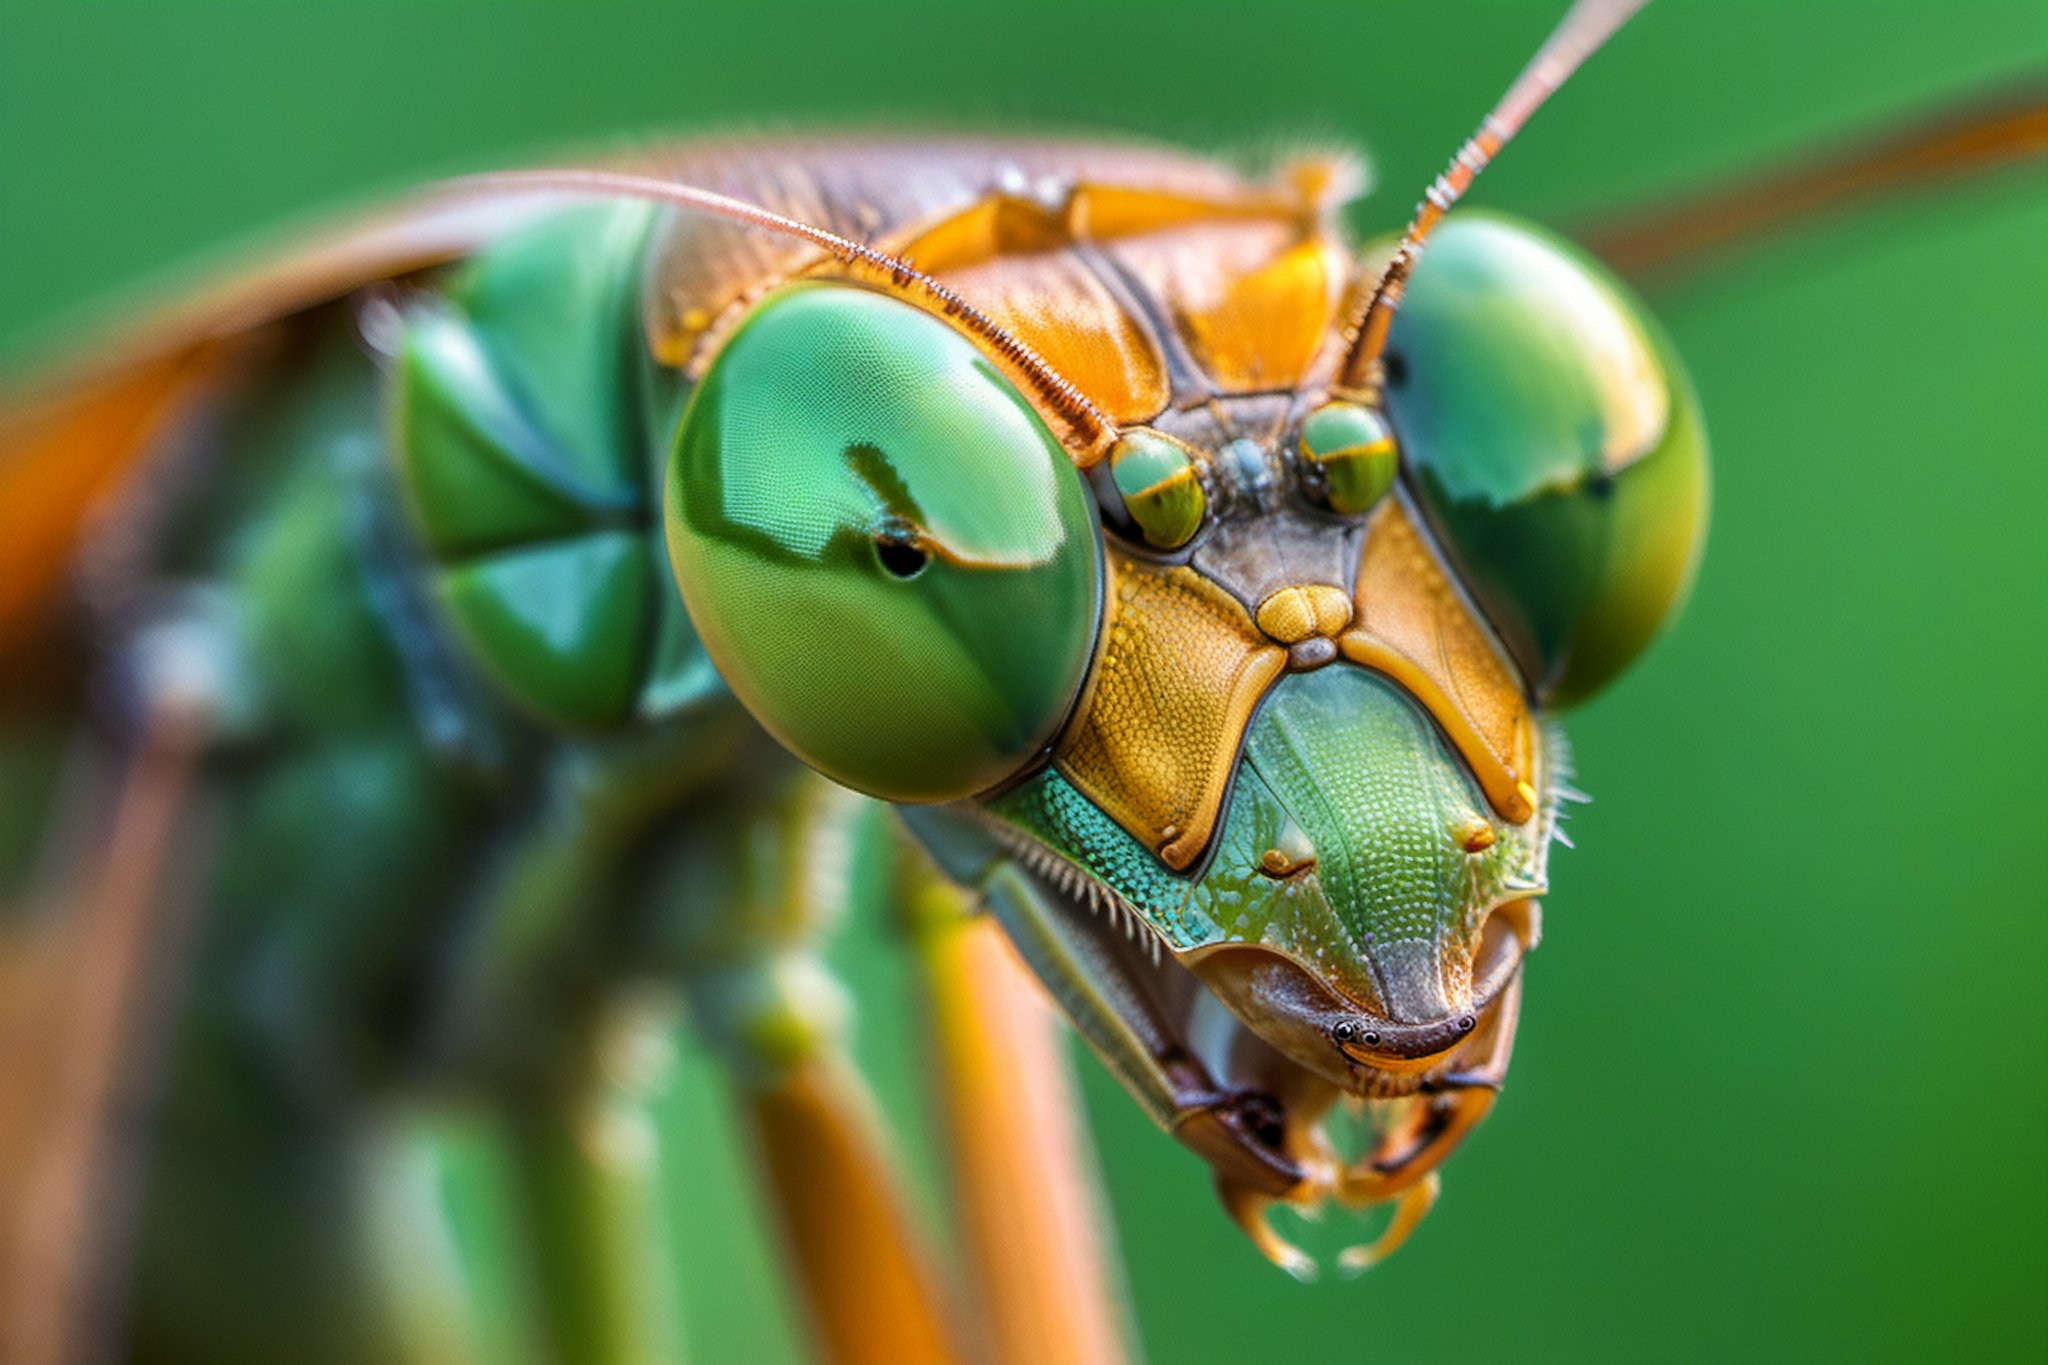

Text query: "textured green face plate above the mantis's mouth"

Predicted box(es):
[989, 667, 1544, 999]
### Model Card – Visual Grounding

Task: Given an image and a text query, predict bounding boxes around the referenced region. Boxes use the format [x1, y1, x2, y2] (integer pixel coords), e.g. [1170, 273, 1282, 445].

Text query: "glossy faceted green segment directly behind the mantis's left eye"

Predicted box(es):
[393, 205, 707, 731]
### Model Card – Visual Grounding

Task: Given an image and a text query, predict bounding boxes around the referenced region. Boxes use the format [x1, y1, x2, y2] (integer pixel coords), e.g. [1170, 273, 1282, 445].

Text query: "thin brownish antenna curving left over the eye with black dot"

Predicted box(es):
[452, 170, 1116, 456]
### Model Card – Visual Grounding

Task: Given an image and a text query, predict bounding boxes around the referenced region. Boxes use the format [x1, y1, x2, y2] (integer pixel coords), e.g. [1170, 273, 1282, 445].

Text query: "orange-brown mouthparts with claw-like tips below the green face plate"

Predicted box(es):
[958, 794, 1540, 1279]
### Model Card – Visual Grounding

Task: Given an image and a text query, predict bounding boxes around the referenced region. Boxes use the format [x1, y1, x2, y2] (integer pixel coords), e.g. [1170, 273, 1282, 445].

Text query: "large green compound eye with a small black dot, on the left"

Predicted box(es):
[666, 284, 1102, 802]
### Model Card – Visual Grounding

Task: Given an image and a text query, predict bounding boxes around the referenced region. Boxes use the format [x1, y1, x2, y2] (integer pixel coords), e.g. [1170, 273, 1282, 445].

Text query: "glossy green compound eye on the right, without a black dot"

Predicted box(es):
[1386, 213, 1706, 704]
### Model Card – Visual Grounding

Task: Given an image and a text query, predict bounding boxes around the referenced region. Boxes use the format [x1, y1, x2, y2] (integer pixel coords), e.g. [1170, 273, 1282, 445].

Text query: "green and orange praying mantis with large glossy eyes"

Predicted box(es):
[4, 6, 2048, 1359]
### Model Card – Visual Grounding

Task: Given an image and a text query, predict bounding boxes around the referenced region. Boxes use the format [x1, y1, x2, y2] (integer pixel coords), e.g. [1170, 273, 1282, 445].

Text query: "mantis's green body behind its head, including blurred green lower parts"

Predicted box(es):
[12, 209, 925, 1365]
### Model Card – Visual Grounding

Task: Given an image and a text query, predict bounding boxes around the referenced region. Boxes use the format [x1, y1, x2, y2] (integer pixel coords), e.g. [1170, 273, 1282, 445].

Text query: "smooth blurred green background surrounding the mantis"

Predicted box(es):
[0, 0, 2048, 1363]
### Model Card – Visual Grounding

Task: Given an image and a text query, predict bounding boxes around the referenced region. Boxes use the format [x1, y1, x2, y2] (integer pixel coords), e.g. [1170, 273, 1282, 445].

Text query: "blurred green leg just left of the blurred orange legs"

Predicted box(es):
[411, 753, 716, 1365]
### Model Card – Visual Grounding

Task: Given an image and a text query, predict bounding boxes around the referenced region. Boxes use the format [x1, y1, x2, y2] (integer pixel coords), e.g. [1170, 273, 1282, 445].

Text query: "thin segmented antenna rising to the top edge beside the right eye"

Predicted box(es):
[1331, 0, 1649, 403]
